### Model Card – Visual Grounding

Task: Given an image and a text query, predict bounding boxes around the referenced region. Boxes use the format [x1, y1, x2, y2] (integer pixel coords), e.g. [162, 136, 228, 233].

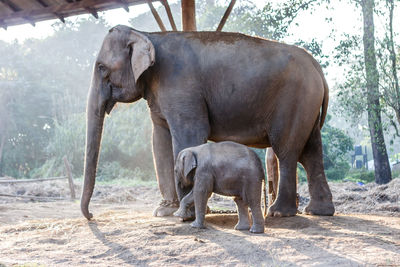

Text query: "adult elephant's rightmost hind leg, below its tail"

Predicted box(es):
[300, 124, 335, 216]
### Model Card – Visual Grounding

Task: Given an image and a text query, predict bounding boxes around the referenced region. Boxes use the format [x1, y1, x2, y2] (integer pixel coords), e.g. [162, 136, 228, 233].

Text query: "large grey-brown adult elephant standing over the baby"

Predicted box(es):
[81, 25, 334, 219]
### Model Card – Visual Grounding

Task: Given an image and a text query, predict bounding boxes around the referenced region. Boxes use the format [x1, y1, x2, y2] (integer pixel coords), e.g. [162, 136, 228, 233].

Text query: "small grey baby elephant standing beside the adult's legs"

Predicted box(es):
[174, 142, 264, 233]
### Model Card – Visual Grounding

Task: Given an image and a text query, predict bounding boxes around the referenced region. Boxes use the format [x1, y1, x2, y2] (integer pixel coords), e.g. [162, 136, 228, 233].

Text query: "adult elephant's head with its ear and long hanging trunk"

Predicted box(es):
[81, 25, 155, 219]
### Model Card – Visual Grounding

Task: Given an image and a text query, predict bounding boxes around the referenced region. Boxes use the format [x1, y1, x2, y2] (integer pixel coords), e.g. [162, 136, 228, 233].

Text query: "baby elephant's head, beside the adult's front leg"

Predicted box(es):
[175, 149, 197, 199]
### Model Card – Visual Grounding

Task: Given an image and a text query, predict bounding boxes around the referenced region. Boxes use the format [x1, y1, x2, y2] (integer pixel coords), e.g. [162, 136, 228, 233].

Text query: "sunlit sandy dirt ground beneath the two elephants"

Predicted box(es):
[0, 179, 400, 266]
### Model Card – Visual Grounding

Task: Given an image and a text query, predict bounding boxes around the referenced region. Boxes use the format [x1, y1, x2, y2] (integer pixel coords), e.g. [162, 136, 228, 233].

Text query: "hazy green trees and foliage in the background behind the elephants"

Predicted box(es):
[0, 0, 400, 185]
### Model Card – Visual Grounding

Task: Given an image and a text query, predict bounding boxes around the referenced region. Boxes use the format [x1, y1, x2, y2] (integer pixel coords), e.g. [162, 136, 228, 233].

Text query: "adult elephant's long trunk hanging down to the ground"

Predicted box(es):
[81, 83, 106, 220]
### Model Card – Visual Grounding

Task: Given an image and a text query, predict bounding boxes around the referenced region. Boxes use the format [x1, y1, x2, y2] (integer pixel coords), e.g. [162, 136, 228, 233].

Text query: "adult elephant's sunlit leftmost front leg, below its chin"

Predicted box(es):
[153, 124, 179, 217]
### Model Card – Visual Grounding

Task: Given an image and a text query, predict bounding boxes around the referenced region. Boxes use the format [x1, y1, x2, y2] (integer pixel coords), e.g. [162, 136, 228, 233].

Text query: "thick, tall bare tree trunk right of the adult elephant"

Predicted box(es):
[361, 0, 392, 184]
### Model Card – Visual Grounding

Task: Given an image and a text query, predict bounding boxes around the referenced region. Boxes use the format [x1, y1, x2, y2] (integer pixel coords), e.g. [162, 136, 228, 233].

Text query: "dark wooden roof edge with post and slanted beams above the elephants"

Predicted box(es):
[0, 0, 236, 31]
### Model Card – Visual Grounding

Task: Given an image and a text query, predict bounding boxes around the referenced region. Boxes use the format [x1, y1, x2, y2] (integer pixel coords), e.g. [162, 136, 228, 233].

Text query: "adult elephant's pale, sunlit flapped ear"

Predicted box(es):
[128, 30, 155, 82]
